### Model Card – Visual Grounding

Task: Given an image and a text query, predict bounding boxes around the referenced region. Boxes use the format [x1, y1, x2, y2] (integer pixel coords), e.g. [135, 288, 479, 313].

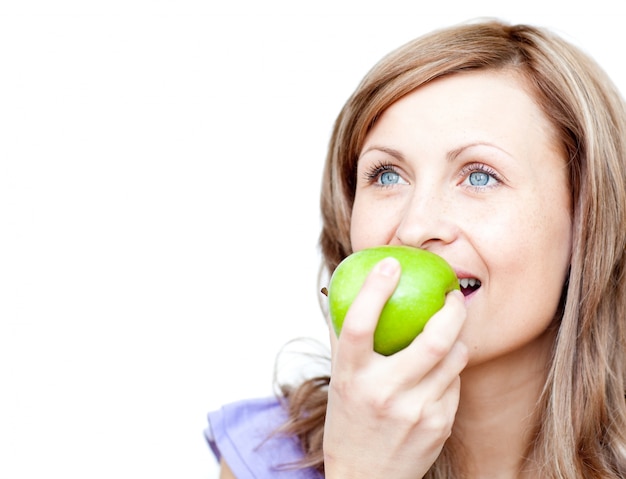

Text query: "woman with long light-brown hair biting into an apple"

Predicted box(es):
[210, 17, 626, 479]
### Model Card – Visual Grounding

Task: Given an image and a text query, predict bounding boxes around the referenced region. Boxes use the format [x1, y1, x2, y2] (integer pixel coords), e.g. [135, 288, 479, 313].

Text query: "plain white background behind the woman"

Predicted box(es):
[0, 0, 626, 479]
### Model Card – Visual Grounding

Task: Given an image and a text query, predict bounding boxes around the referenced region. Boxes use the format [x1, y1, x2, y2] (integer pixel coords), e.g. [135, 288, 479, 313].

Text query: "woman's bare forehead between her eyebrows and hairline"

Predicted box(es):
[363, 70, 557, 156]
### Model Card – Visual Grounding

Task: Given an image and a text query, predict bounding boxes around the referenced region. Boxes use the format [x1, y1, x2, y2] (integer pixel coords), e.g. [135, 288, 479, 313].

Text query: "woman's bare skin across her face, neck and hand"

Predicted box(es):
[324, 71, 572, 479]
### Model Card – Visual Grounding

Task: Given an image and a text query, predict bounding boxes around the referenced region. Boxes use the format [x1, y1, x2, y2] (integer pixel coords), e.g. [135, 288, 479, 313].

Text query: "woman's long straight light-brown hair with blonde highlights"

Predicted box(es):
[283, 20, 626, 479]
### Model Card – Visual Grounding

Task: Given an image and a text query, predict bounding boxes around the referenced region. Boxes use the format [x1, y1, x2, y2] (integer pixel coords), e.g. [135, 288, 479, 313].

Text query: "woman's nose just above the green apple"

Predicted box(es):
[396, 190, 459, 249]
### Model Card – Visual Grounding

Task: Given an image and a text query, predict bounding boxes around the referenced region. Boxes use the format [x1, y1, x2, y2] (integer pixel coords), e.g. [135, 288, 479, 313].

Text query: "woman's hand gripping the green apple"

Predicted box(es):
[324, 258, 467, 479]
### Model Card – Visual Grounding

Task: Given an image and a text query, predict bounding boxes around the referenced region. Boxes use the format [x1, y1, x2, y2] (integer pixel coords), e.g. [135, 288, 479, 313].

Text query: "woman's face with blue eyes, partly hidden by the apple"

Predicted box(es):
[351, 71, 571, 364]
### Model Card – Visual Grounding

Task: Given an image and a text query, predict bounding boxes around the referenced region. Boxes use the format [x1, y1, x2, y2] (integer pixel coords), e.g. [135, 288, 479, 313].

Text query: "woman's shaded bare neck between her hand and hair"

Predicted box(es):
[453, 332, 554, 479]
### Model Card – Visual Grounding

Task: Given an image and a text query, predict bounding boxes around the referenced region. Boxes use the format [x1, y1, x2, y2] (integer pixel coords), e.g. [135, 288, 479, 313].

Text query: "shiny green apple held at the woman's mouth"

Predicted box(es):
[327, 245, 460, 356]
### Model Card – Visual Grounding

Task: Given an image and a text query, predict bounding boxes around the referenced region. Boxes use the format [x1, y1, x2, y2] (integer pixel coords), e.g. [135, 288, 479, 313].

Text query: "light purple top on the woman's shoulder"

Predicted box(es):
[205, 398, 324, 479]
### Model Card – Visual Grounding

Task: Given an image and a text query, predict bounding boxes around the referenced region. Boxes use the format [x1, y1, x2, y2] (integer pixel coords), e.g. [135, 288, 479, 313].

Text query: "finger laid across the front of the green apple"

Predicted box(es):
[337, 257, 400, 367]
